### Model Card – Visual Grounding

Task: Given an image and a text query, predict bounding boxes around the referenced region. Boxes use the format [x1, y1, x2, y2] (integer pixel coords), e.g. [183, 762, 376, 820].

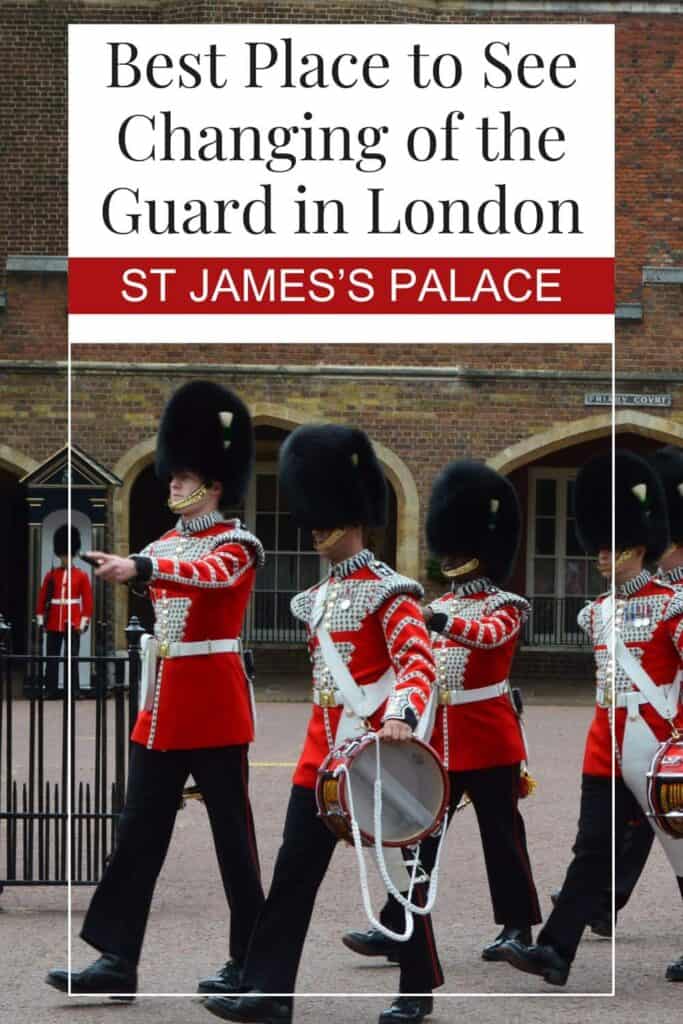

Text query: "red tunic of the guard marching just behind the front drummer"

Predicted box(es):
[430, 579, 528, 771]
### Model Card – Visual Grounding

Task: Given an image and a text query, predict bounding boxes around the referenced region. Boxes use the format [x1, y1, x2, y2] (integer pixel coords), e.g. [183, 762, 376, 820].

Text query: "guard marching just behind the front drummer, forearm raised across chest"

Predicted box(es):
[343, 460, 541, 961]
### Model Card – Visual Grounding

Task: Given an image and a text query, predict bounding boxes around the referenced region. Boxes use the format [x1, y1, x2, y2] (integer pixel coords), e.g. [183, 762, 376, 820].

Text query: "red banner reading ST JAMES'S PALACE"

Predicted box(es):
[69, 257, 614, 316]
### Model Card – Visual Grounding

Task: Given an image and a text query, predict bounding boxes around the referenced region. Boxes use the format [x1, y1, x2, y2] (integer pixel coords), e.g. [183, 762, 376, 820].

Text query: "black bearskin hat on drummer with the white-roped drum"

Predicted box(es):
[280, 423, 387, 529]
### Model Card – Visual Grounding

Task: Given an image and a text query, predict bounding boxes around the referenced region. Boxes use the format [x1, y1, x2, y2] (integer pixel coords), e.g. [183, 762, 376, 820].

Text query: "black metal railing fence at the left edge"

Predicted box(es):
[0, 615, 142, 890]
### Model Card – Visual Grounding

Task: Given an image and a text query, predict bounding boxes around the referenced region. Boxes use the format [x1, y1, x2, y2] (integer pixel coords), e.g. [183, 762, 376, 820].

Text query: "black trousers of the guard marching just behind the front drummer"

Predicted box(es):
[380, 764, 541, 931]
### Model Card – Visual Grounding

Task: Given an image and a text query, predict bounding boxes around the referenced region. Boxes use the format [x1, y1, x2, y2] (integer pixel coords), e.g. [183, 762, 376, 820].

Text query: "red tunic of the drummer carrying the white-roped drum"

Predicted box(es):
[292, 550, 434, 790]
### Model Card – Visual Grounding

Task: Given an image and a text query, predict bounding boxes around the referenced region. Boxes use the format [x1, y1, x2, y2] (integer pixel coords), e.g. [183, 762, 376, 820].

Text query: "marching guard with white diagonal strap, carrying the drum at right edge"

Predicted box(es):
[502, 452, 683, 985]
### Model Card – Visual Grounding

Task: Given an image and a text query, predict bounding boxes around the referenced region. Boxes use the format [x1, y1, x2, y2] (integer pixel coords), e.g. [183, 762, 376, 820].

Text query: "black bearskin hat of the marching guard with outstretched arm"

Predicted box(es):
[155, 381, 254, 505]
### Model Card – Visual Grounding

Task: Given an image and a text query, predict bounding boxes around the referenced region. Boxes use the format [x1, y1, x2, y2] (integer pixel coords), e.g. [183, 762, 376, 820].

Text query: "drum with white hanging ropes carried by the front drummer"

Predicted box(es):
[315, 733, 450, 847]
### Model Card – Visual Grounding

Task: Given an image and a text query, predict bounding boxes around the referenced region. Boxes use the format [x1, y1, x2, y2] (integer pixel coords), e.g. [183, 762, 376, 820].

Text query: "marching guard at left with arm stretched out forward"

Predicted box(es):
[47, 381, 263, 994]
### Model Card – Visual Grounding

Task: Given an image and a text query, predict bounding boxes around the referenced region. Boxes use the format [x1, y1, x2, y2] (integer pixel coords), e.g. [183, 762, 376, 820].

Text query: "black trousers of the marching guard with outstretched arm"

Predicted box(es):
[81, 743, 263, 964]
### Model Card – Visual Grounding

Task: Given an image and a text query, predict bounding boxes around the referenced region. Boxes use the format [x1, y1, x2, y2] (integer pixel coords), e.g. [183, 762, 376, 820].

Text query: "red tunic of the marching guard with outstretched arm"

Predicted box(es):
[127, 513, 263, 751]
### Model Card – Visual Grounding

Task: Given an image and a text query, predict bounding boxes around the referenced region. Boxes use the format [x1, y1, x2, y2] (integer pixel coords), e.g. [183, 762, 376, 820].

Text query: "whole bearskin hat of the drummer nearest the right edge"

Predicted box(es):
[574, 450, 669, 559]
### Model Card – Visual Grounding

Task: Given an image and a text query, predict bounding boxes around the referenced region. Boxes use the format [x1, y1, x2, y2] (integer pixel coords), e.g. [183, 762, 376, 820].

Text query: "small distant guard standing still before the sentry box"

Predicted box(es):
[36, 522, 92, 699]
